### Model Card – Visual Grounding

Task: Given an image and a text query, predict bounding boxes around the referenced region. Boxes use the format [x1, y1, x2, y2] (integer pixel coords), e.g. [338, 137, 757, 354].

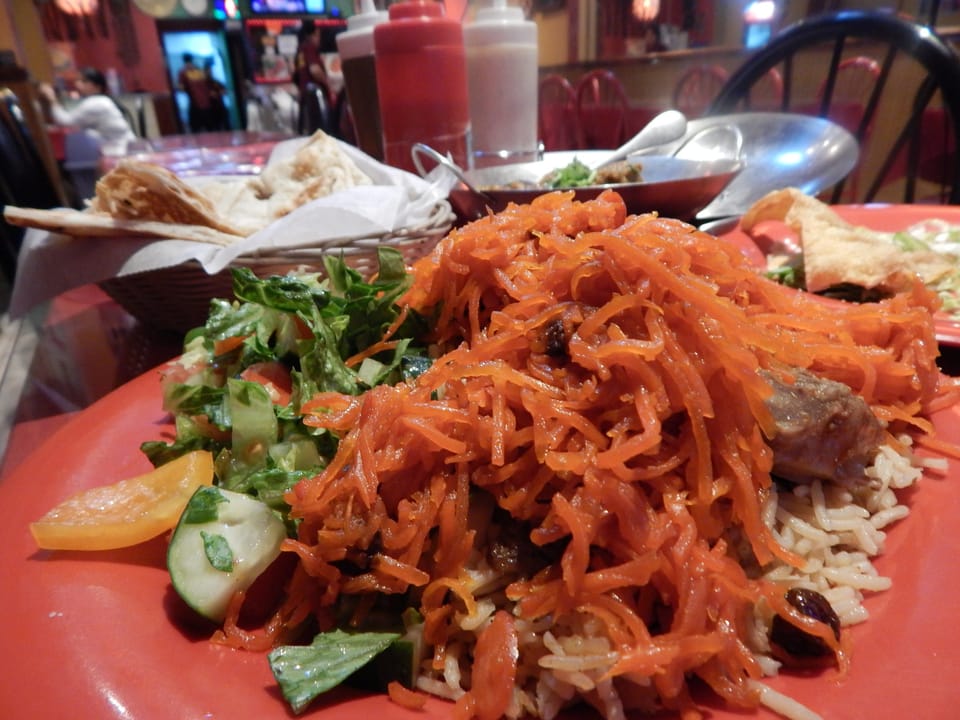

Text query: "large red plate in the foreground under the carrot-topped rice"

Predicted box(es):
[0, 366, 960, 720]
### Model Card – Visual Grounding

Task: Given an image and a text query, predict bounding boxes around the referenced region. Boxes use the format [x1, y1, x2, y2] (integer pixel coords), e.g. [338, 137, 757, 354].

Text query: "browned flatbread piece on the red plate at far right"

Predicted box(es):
[740, 188, 956, 293]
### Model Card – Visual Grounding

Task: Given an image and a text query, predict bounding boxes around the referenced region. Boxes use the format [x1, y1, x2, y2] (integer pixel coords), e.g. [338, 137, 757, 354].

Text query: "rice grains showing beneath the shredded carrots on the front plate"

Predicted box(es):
[417, 438, 946, 720]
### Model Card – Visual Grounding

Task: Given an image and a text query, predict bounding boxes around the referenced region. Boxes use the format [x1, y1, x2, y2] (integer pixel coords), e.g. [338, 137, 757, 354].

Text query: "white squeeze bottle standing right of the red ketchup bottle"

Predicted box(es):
[463, 0, 538, 167]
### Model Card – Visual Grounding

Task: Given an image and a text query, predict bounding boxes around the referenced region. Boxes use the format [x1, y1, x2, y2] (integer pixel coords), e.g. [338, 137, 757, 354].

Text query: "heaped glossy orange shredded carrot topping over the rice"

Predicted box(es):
[258, 192, 957, 717]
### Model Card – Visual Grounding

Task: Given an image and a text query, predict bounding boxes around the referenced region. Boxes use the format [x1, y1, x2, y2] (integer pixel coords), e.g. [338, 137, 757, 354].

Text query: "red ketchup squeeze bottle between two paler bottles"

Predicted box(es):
[373, 0, 471, 172]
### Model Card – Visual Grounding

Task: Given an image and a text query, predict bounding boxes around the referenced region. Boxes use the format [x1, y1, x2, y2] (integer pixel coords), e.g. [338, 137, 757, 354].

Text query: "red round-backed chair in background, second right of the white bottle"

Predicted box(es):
[577, 70, 630, 149]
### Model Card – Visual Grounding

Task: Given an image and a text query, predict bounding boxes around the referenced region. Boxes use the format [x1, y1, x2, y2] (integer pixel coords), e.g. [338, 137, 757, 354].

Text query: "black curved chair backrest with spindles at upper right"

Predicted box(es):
[707, 10, 960, 204]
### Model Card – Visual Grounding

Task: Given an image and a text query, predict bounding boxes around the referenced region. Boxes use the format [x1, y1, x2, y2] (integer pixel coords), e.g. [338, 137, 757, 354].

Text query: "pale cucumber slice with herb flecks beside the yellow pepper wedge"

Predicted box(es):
[167, 486, 287, 622]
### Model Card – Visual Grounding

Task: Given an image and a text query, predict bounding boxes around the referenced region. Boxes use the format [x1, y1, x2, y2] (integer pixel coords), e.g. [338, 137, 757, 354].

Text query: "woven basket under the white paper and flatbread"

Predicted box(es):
[100, 200, 454, 335]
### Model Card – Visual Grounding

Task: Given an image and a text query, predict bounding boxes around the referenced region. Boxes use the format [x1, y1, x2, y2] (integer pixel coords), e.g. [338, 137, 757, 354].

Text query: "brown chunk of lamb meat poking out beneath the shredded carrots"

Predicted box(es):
[761, 369, 885, 483]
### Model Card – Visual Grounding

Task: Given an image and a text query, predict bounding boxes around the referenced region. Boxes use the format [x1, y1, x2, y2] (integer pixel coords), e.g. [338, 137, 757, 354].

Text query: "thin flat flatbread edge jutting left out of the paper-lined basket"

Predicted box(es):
[3, 205, 238, 245]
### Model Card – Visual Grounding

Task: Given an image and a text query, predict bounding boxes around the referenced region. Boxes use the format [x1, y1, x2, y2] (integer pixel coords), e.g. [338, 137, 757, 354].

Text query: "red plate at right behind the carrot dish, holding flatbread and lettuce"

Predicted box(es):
[720, 205, 960, 346]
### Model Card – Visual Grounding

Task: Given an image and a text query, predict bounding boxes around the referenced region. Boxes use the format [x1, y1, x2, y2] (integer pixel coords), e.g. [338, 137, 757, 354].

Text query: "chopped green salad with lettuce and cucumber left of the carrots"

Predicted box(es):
[142, 249, 430, 712]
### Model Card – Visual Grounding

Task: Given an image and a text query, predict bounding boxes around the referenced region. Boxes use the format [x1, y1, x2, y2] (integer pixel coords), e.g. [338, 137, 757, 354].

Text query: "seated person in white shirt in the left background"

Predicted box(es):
[38, 67, 137, 153]
